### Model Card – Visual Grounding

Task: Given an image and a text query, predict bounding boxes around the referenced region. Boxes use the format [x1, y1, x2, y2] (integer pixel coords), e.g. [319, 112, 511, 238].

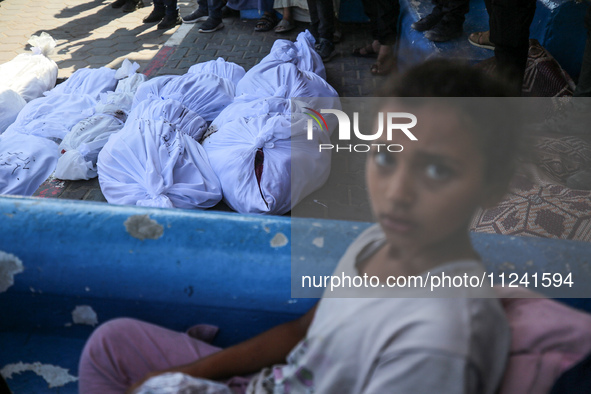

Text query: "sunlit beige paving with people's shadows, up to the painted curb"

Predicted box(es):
[0, 0, 196, 78]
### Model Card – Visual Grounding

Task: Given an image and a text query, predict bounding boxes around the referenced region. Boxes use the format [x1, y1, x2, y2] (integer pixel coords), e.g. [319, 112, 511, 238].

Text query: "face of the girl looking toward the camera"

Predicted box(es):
[366, 104, 490, 257]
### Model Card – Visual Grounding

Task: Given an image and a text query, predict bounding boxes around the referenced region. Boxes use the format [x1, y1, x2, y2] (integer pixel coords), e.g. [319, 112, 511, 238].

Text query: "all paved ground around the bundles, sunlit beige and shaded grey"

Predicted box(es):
[0, 0, 384, 220]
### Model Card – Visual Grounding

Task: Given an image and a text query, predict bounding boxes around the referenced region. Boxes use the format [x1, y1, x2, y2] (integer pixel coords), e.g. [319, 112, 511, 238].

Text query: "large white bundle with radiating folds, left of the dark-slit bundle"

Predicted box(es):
[97, 100, 222, 208]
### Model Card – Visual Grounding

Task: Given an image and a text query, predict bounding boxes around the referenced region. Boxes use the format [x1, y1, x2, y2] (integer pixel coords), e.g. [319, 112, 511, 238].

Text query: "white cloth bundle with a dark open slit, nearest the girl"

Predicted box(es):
[203, 113, 330, 214]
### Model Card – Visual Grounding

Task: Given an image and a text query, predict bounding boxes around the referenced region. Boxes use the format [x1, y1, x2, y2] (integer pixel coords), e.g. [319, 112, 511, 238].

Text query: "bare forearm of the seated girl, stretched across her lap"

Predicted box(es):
[128, 305, 317, 392]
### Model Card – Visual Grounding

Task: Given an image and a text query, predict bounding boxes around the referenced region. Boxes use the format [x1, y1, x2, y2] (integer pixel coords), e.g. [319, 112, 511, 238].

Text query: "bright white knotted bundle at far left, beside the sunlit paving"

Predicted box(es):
[0, 32, 57, 102]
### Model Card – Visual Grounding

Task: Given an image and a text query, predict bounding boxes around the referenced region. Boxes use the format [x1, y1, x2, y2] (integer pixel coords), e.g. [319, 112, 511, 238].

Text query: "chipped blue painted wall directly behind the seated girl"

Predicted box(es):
[0, 197, 591, 393]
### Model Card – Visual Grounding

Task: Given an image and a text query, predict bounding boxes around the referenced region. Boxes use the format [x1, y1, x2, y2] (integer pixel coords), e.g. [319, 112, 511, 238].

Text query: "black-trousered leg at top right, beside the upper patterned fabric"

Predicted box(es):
[487, 0, 536, 96]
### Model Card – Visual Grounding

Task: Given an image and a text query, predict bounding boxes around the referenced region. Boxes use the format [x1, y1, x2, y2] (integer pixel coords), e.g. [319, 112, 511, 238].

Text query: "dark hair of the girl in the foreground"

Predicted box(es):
[380, 59, 521, 192]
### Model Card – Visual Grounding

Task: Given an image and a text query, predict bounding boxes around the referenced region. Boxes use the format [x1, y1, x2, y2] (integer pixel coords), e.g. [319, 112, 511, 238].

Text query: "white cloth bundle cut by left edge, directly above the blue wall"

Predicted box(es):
[0, 133, 58, 196]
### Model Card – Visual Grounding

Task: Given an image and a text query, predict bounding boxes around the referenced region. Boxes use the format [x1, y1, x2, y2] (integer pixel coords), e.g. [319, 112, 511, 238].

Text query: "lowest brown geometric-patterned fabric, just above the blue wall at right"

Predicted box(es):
[470, 175, 591, 241]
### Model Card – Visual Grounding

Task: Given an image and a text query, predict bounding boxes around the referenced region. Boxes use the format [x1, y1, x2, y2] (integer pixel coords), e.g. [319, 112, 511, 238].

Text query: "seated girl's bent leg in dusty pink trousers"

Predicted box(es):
[79, 319, 220, 394]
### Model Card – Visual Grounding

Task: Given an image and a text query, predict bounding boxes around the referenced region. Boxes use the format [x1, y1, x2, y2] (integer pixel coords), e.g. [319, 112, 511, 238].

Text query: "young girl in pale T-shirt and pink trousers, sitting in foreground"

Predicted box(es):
[79, 61, 516, 394]
